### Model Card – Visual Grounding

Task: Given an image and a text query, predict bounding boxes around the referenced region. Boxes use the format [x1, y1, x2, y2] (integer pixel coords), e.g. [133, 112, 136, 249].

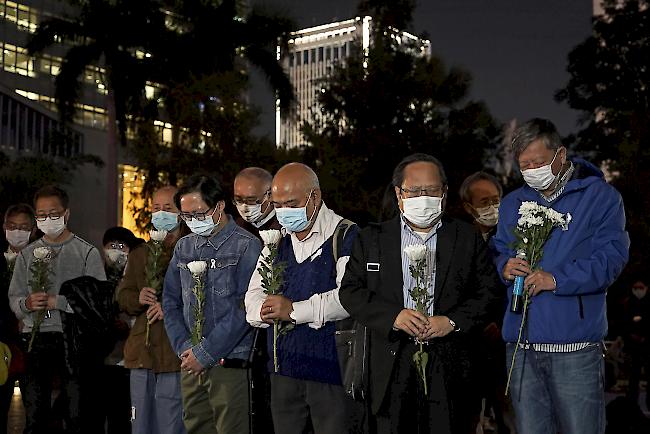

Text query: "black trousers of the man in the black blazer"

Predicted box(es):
[375, 342, 453, 434]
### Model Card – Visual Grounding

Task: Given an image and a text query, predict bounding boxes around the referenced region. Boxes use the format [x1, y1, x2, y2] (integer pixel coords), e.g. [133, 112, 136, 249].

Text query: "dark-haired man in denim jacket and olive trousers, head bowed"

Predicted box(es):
[163, 175, 261, 434]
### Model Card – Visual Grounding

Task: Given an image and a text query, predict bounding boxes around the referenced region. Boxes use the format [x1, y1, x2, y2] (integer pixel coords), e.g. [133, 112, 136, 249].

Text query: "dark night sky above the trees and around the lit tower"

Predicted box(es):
[251, 0, 592, 137]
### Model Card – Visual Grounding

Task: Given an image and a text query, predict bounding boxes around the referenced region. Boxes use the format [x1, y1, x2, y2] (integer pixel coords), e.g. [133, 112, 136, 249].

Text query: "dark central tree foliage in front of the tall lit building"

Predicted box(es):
[303, 1, 500, 221]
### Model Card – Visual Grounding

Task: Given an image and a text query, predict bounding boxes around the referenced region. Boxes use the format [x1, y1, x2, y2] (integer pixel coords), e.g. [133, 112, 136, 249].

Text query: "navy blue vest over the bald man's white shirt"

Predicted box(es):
[267, 227, 356, 385]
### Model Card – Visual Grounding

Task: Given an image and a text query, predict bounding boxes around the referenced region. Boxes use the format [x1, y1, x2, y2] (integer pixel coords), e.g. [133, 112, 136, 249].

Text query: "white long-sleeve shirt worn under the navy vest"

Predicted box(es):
[244, 202, 350, 329]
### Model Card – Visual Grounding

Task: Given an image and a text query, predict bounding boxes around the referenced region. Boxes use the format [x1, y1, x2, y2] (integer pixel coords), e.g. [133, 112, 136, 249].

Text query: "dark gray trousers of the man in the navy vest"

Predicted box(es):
[271, 374, 350, 434]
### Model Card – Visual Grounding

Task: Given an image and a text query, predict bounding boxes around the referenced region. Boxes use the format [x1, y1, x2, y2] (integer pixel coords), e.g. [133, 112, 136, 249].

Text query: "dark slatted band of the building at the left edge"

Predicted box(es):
[0, 94, 83, 157]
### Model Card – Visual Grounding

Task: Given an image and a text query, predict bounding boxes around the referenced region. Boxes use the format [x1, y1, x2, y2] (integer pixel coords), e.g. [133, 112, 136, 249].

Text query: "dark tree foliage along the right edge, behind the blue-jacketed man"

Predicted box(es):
[556, 0, 650, 271]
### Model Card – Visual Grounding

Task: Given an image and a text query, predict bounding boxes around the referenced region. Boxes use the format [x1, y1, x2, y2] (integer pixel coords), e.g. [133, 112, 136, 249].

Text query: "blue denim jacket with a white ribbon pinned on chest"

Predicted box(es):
[162, 216, 262, 368]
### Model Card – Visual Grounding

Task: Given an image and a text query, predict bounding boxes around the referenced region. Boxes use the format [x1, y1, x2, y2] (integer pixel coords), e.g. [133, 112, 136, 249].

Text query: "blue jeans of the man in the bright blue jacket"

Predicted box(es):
[507, 344, 605, 434]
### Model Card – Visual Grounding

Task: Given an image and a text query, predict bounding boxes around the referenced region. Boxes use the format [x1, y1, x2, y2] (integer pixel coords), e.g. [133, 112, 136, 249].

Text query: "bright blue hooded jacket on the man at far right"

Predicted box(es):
[491, 158, 630, 344]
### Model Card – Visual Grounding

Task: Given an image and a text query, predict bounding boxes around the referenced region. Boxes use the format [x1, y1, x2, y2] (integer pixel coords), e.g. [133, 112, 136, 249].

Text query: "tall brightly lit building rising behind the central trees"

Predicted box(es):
[275, 16, 431, 147]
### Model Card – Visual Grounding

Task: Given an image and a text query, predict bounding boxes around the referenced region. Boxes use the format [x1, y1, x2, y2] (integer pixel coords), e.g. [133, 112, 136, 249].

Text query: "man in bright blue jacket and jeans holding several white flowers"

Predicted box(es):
[492, 119, 630, 434]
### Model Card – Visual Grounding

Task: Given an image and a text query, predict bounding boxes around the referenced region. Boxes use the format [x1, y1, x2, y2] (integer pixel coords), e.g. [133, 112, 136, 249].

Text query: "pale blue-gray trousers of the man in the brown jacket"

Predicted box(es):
[131, 369, 186, 434]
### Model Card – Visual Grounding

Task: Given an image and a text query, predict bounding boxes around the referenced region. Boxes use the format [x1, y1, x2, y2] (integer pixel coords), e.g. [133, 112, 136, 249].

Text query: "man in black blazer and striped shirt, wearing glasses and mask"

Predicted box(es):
[339, 154, 505, 433]
